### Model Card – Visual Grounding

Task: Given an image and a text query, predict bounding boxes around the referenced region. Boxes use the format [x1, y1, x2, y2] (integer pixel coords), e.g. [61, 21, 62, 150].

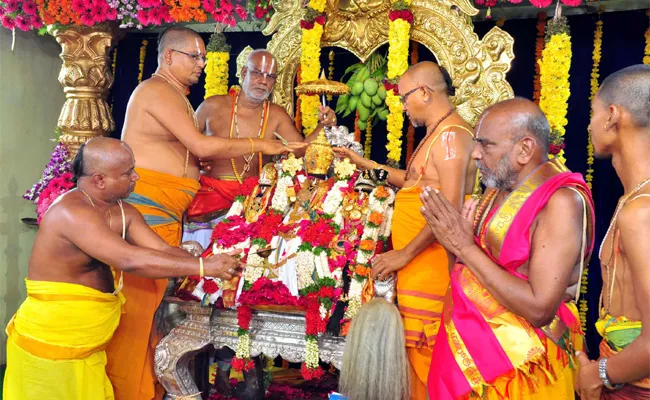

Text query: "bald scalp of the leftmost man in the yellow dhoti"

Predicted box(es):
[72, 137, 133, 182]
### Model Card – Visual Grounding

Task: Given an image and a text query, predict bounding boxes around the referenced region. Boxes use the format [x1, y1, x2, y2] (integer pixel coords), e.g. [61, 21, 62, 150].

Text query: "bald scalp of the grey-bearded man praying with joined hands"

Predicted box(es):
[476, 97, 551, 153]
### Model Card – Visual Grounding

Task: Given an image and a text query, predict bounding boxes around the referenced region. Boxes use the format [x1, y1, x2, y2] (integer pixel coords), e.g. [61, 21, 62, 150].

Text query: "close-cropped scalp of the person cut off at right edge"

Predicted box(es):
[598, 64, 650, 128]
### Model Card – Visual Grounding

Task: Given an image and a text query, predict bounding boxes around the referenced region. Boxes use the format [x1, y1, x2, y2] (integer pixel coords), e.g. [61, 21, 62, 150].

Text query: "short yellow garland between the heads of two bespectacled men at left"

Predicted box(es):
[204, 32, 230, 99]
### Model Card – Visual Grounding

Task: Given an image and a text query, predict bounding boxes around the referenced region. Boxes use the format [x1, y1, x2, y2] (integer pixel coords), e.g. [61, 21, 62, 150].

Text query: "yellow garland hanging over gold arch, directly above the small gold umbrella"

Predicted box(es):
[300, 0, 325, 136]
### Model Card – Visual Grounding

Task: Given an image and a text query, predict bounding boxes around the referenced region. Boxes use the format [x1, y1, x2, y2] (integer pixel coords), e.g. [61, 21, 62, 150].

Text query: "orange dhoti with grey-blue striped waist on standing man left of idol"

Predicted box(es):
[106, 168, 199, 400]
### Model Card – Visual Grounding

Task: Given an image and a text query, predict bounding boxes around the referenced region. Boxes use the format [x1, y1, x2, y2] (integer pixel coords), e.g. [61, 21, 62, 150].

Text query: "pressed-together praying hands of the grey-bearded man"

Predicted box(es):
[420, 187, 477, 256]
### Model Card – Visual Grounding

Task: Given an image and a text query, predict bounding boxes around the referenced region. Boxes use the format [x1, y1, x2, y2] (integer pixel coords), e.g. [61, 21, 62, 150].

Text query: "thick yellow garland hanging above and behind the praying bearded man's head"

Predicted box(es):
[539, 16, 571, 162]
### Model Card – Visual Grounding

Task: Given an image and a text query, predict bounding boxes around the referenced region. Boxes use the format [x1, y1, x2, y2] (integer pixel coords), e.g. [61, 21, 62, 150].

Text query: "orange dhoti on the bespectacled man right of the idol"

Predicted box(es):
[392, 188, 449, 399]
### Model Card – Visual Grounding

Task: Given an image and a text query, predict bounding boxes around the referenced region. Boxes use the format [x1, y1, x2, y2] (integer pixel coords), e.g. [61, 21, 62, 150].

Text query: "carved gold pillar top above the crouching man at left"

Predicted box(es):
[50, 25, 115, 157]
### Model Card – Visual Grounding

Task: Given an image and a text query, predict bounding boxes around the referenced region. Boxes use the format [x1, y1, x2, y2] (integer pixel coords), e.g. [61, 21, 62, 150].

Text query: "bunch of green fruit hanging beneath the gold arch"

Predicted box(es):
[336, 53, 388, 130]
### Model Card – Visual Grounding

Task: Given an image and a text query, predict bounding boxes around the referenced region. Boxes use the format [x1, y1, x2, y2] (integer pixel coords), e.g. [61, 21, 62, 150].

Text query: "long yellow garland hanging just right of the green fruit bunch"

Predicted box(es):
[384, 0, 413, 167]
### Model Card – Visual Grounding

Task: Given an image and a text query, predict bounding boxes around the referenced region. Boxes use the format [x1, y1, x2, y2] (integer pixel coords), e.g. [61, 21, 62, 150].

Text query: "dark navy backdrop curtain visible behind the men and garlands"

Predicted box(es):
[110, 10, 648, 356]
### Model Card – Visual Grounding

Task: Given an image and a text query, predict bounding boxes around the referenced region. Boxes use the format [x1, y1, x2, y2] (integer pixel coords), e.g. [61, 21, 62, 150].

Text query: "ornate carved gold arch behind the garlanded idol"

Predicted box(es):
[253, 0, 514, 124]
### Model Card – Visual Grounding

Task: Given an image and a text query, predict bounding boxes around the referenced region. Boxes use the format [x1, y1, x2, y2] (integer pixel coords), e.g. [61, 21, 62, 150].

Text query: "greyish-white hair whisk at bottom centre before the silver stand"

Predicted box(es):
[339, 299, 411, 400]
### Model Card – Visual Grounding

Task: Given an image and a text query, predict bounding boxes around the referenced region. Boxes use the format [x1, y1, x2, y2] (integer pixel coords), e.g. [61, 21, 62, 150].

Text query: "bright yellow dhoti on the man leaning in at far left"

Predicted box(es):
[3, 279, 122, 400]
